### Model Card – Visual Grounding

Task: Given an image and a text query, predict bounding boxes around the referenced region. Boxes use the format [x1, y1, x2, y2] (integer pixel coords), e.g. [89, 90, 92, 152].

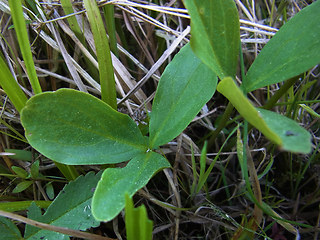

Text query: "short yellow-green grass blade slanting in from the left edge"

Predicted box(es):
[0, 56, 28, 112]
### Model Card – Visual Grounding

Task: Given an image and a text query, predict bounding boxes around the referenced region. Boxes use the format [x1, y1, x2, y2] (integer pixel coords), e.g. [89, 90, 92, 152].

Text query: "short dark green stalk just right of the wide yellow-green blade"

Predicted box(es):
[103, 4, 119, 57]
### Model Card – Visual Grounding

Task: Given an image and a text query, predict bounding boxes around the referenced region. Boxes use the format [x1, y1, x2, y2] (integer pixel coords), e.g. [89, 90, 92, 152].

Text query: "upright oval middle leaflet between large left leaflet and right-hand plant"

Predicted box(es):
[150, 45, 217, 148]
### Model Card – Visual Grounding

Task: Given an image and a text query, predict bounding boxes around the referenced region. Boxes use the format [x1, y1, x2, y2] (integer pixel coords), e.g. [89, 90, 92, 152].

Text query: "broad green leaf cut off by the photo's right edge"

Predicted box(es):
[242, 1, 320, 92]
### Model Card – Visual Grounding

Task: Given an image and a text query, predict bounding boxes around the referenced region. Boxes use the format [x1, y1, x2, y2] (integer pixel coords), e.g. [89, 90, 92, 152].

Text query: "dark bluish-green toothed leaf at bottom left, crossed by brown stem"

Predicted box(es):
[25, 172, 101, 239]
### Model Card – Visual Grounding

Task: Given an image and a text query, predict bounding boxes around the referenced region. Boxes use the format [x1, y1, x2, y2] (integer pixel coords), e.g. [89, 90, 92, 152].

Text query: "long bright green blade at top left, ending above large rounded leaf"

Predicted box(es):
[9, 0, 42, 94]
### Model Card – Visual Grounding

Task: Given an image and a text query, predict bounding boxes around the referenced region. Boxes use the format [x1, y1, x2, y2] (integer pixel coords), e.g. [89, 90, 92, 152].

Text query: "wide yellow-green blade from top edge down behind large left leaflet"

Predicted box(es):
[83, 0, 117, 110]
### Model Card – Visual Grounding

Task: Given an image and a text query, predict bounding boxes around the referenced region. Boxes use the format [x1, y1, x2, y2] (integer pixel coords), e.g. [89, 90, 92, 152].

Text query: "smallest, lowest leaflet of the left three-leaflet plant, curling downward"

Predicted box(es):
[92, 152, 170, 221]
